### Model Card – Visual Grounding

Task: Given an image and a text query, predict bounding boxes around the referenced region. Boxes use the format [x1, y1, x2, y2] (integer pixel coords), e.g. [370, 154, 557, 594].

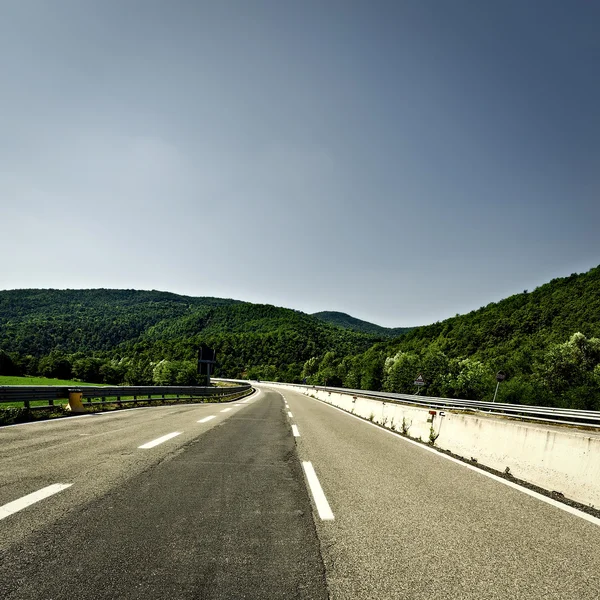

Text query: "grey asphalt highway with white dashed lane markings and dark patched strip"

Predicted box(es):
[0, 386, 600, 600]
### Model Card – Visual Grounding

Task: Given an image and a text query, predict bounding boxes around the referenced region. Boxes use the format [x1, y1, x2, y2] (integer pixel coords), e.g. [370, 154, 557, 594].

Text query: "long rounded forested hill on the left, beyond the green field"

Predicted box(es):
[0, 290, 383, 385]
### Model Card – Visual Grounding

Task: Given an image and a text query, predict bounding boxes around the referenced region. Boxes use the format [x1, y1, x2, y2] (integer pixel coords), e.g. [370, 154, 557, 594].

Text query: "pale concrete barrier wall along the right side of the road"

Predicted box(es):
[274, 384, 600, 508]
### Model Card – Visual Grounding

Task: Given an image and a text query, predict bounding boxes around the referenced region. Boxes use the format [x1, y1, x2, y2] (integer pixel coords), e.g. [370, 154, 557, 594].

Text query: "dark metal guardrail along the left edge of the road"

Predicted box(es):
[0, 383, 251, 410]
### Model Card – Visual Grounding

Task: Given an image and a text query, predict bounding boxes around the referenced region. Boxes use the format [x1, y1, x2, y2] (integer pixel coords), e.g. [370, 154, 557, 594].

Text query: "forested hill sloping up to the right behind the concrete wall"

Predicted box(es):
[312, 267, 600, 410]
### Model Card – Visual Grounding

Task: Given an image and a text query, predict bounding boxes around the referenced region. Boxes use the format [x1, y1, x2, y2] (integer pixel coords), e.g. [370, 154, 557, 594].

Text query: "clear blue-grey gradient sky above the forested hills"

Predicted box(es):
[0, 0, 600, 326]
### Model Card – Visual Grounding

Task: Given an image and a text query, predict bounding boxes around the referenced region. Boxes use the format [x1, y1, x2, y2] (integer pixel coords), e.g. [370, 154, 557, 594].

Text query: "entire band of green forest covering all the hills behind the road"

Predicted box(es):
[0, 267, 600, 410]
